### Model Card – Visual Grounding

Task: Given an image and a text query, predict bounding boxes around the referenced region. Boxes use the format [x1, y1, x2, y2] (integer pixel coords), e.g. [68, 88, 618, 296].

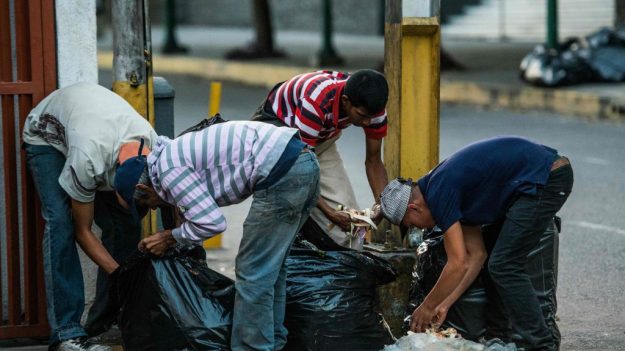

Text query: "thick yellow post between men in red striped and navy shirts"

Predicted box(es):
[376, 0, 440, 244]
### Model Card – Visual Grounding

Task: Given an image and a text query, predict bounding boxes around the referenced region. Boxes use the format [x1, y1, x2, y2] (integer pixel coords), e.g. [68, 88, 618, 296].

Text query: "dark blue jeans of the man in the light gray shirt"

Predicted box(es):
[24, 144, 141, 345]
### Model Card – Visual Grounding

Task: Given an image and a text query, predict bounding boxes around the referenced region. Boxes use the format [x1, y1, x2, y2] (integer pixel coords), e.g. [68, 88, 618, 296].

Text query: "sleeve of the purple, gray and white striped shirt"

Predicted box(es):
[160, 167, 227, 244]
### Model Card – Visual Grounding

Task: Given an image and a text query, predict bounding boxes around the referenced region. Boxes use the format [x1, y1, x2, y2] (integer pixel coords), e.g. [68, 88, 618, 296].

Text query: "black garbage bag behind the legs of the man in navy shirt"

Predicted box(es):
[404, 217, 561, 345]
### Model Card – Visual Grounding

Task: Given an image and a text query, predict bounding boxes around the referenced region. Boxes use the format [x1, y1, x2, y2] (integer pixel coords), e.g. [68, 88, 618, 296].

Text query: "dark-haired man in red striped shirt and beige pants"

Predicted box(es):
[252, 70, 388, 249]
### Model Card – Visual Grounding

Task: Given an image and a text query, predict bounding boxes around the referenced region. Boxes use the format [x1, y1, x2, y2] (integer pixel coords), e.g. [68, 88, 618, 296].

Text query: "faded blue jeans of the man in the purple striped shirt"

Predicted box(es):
[231, 152, 319, 351]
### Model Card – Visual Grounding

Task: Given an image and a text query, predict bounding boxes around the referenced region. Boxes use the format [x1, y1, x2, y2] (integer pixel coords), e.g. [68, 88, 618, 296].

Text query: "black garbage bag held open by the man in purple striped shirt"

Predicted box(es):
[117, 245, 234, 351]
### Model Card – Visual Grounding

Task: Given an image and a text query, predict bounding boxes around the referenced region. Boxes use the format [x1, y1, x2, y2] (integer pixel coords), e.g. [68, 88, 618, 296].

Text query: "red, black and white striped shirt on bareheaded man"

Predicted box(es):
[267, 71, 387, 146]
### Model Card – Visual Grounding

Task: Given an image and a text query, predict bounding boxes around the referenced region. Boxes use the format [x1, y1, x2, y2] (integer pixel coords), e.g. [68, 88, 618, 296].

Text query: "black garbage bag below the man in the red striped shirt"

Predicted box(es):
[285, 238, 396, 351]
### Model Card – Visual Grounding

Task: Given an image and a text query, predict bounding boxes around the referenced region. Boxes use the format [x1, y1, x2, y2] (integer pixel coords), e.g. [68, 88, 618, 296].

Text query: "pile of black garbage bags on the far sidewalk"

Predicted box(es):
[520, 27, 625, 87]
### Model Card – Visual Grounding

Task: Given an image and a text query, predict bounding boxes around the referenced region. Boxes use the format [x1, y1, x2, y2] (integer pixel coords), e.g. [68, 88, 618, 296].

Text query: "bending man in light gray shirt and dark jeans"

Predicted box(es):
[23, 83, 156, 351]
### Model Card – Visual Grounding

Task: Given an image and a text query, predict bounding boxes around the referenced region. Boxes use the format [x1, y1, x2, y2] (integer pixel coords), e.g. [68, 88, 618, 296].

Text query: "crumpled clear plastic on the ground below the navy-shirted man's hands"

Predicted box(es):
[383, 332, 517, 351]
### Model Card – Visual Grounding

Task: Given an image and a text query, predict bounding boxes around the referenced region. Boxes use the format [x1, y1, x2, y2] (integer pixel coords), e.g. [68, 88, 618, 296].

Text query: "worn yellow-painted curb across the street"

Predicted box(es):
[98, 51, 625, 122]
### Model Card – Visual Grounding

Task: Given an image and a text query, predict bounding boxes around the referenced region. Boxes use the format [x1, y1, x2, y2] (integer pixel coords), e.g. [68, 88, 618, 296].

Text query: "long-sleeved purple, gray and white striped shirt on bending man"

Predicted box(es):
[147, 121, 297, 244]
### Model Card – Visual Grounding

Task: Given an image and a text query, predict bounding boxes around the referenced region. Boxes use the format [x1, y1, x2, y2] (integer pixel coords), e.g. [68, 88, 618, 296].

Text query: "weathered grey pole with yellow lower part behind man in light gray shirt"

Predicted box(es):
[111, 0, 156, 236]
